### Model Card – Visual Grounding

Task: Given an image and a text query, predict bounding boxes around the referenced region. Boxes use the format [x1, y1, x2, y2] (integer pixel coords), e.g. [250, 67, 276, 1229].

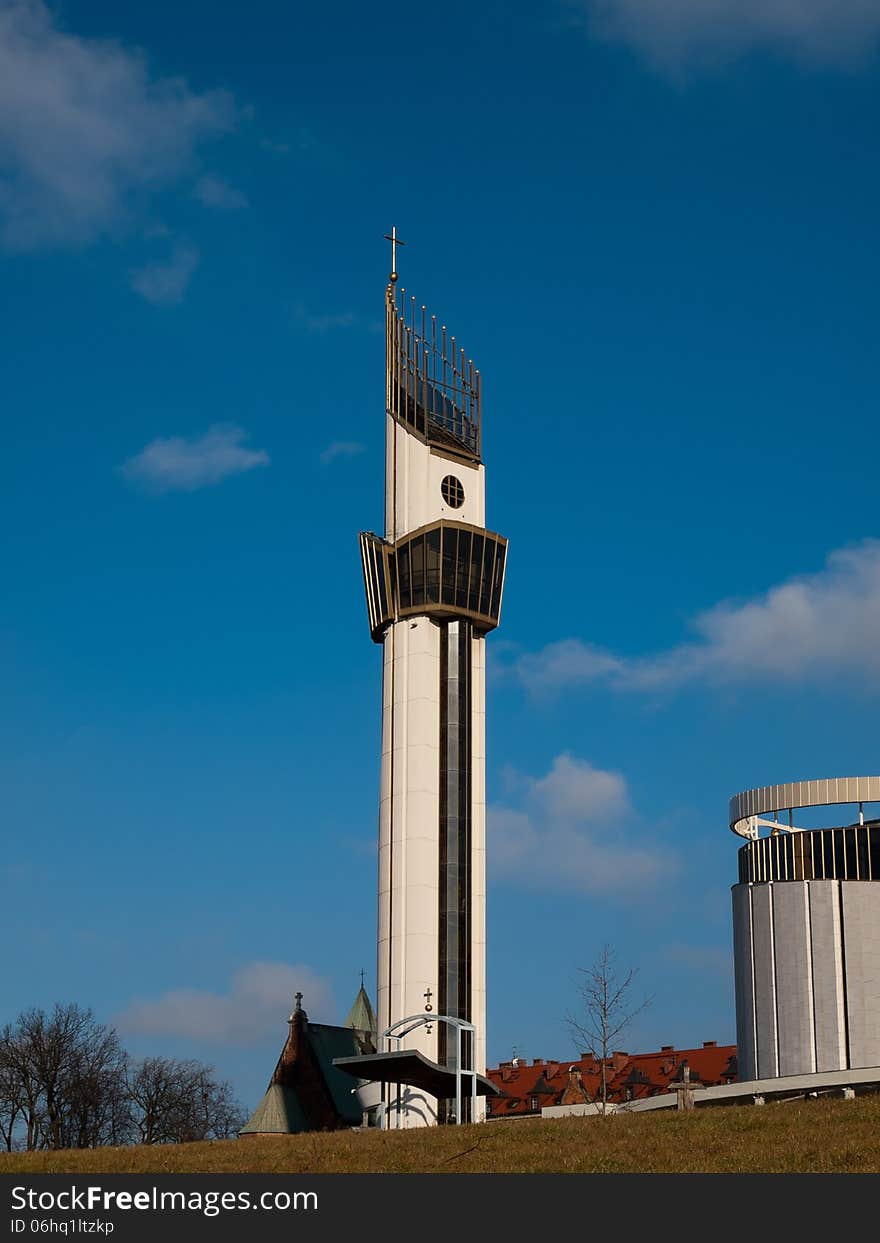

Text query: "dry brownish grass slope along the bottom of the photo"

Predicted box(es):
[0, 1096, 880, 1173]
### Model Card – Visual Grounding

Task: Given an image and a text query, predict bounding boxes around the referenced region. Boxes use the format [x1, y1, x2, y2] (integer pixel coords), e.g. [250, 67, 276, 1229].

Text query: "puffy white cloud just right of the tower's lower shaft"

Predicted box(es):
[487, 755, 675, 899]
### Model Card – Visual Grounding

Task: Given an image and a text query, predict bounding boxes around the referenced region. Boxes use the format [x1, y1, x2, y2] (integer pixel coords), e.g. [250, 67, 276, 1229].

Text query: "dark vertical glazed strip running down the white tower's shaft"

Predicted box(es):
[438, 620, 472, 1118]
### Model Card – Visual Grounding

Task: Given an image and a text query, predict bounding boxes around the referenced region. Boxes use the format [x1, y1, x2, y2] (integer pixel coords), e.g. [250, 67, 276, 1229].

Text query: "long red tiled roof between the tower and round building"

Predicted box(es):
[486, 1040, 737, 1117]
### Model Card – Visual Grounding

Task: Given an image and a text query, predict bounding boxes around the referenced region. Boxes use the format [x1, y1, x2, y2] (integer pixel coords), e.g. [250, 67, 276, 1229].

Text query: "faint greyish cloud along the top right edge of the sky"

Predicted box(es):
[574, 0, 880, 70]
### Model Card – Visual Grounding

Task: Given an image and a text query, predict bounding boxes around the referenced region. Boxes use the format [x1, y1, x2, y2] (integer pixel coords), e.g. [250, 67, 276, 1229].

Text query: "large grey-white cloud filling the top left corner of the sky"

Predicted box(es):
[0, 0, 236, 249]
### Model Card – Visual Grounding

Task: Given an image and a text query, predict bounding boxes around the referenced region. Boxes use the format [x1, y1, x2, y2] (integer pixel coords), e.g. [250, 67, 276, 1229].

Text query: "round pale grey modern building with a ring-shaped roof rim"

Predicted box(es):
[730, 777, 880, 1080]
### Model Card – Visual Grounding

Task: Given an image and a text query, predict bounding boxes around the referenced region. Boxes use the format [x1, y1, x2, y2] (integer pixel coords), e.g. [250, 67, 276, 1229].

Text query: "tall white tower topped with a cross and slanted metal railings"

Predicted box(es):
[360, 232, 507, 1126]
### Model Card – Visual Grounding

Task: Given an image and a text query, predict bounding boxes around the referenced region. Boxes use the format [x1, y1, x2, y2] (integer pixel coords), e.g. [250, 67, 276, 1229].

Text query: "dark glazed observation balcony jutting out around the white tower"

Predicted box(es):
[360, 520, 507, 643]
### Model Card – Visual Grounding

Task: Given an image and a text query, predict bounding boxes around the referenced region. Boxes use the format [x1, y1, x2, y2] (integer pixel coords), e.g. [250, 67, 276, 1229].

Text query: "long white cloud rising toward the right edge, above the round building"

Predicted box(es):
[513, 539, 880, 692]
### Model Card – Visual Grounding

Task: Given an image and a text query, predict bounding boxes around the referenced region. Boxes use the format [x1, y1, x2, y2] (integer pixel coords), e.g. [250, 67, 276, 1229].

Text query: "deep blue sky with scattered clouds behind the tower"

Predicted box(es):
[0, 0, 880, 1105]
